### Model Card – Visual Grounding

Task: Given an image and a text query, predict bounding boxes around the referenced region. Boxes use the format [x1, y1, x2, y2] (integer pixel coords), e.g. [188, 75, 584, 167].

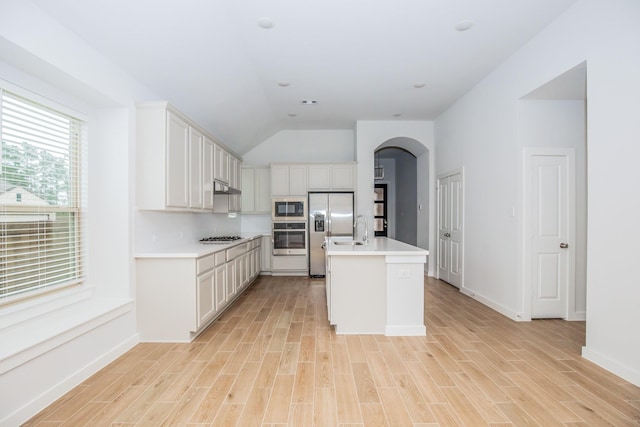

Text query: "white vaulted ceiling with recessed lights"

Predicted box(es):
[34, 0, 576, 154]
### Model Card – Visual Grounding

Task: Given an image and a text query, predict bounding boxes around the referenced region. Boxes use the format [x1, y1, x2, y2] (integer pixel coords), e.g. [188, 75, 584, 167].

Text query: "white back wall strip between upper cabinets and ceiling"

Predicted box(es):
[242, 129, 355, 166]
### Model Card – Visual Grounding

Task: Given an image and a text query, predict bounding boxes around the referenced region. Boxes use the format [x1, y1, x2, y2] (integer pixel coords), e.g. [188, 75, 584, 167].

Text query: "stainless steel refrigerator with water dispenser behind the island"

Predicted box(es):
[308, 193, 353, 276]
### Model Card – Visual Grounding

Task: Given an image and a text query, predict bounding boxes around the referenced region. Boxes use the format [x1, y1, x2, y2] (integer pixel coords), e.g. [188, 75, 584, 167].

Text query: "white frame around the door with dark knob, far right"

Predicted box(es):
[516, 147, 577, 321]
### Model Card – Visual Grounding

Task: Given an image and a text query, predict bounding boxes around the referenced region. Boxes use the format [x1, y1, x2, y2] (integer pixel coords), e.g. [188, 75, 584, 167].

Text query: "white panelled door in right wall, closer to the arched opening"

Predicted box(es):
[438, 173, 463, 288]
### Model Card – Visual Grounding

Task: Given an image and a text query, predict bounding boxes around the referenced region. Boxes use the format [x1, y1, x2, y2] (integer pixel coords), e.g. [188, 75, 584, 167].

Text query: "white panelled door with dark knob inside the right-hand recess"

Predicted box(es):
[527, 152, 575, 318]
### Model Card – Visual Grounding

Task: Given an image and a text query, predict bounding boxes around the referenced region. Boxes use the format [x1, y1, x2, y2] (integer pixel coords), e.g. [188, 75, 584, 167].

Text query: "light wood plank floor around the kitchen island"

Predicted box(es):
[25, 276, 640, 427]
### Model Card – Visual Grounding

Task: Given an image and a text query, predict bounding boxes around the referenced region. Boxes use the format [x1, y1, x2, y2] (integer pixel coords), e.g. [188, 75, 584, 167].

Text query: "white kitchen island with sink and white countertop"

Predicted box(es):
[325, 237, 429, 336]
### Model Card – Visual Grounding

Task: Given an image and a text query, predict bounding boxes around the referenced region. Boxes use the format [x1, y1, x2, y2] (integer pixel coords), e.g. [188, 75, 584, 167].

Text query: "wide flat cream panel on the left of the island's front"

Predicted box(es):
[329, 256, 387, 334]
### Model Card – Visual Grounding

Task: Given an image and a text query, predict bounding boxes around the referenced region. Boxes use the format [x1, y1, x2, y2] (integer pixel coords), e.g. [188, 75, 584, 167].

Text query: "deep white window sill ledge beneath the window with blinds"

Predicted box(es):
[0, 294, 134, 375]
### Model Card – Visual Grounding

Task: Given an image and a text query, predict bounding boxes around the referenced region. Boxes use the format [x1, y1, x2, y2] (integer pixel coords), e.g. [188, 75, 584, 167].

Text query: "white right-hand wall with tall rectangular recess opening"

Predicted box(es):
[435, 0, 640, 385]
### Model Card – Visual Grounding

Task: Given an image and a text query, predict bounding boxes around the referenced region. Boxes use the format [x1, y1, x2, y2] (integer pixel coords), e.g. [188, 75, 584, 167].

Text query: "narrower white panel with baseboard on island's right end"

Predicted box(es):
[385, 256, 427, 336]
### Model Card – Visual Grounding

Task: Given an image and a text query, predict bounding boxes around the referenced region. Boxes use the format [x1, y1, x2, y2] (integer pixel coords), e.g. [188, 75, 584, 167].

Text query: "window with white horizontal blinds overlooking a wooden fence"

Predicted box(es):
[0, 88, 84, 304]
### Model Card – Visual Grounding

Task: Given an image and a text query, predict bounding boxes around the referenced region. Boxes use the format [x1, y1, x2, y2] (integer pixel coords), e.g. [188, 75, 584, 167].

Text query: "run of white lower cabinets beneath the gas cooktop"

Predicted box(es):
[136, 236, 262, 342]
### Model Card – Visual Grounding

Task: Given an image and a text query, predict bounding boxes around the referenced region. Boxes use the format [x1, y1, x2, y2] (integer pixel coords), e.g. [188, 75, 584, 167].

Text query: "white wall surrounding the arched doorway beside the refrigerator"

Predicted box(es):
[356, 120, 436, 276]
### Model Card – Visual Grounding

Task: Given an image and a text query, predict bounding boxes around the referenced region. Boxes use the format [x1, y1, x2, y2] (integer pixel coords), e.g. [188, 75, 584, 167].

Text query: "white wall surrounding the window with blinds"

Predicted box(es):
[0, 0, 154, 426]
